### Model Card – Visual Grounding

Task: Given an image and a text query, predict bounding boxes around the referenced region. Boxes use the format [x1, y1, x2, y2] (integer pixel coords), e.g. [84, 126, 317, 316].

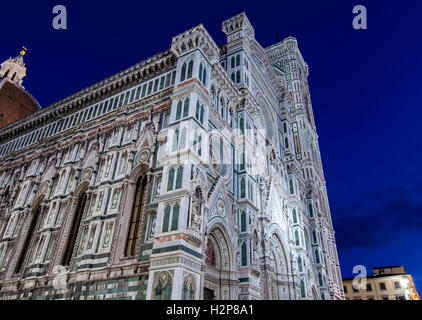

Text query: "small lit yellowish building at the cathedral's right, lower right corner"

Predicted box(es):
[343, 266, 420, 300]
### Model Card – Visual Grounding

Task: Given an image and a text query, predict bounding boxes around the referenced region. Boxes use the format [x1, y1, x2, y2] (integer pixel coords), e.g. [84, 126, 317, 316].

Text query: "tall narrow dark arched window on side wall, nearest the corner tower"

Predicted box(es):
[125, 176, 147, 257]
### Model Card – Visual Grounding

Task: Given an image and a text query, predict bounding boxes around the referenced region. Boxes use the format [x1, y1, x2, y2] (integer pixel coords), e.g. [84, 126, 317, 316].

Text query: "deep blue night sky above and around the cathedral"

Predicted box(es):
[0, 0, 422, 293]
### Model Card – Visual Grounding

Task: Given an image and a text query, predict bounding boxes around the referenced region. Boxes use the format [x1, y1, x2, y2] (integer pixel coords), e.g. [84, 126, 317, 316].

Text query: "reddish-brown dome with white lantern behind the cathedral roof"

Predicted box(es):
[0, 50, 41, 128]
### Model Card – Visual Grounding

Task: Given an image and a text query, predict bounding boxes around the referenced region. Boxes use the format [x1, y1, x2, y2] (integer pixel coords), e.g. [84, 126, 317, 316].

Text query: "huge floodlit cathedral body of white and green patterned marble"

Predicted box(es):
[0, 13, 344, 300]
